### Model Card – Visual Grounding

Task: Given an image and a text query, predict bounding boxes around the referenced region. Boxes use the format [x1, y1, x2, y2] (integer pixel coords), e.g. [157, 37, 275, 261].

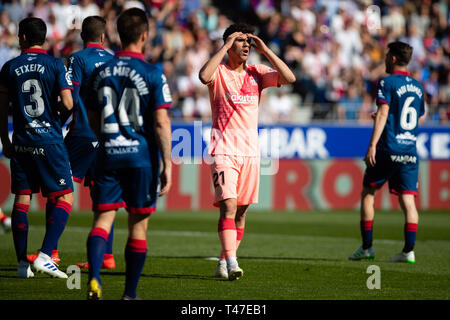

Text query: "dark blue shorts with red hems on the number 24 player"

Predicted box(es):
[91, 166, 159, 214]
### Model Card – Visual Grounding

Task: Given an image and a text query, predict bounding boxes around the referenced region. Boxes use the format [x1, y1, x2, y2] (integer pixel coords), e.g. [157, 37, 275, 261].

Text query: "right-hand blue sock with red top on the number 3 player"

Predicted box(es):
[41, 201, 72, 256]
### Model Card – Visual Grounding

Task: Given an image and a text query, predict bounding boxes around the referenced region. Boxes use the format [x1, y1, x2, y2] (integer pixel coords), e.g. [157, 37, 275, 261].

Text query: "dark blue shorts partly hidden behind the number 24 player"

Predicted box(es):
[64, 136, 98, 186]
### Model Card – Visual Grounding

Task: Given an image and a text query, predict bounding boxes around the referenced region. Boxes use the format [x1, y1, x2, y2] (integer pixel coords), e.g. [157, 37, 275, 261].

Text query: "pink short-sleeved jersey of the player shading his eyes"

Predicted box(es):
[208, 63, 278, 157]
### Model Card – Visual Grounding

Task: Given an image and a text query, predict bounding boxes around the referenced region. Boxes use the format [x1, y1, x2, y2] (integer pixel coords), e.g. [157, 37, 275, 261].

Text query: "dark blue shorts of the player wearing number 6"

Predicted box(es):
[363, 150, 419, 196]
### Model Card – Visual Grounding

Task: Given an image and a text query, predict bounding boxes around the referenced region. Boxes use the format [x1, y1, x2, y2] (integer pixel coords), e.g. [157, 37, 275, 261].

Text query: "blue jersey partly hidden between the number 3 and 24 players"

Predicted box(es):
[68, 44, 114, 138]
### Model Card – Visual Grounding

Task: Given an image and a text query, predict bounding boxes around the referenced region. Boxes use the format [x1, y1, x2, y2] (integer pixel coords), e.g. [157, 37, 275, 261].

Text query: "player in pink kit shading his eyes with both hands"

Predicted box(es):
[199, 23, 295, 280]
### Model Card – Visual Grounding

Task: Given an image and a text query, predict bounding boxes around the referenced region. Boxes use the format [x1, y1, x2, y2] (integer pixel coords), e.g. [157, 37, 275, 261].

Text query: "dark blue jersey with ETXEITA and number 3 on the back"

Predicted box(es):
[0, 49, 72, 146]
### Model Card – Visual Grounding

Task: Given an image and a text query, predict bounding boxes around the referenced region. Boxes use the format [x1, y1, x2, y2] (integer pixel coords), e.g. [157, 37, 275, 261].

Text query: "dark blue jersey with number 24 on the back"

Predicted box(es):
[87, 51, 172, 169]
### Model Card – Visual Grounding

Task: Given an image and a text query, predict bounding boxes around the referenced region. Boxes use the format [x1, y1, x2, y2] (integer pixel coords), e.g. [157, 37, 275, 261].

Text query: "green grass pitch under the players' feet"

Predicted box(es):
[0, 211, 450, 300]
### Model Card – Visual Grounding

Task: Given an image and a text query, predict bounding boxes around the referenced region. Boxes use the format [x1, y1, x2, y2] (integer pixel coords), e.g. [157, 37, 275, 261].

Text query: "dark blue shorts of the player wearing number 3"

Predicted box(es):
[10, 143, 73, 197]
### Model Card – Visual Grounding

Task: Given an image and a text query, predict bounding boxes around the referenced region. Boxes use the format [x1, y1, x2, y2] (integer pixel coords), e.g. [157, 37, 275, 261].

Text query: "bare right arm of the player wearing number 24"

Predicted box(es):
[155, 109, 172, 197]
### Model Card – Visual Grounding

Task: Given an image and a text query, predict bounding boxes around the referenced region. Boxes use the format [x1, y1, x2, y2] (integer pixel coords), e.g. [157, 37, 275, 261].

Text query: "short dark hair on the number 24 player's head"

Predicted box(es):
[117, 8, 148, 47]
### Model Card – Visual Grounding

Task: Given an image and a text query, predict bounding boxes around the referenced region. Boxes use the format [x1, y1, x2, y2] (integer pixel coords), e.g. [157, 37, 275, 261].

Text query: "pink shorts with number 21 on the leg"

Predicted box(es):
[211, 155, 260, 207]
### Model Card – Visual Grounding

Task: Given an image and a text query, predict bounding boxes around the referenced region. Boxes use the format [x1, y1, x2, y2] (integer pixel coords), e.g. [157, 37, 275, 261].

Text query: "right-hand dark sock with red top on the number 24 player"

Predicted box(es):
[124, 238, 147, 298]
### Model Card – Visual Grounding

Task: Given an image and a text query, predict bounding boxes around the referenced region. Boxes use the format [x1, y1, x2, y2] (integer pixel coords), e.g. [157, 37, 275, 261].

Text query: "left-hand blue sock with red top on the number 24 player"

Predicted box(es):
[87, 228, 108, 282]
